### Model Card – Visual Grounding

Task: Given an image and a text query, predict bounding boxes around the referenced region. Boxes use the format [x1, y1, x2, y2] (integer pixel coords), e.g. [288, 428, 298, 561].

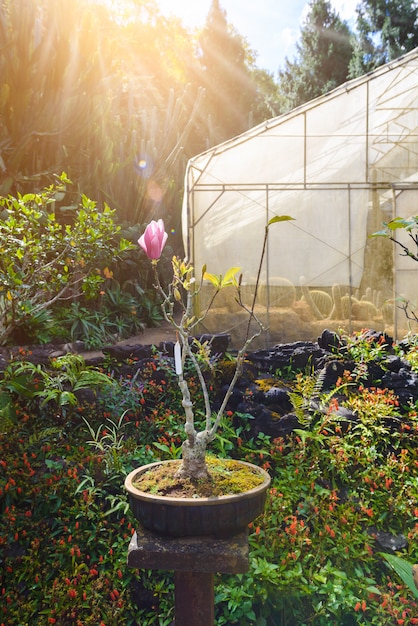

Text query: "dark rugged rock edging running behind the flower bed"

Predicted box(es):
[4, 330, 418, 446]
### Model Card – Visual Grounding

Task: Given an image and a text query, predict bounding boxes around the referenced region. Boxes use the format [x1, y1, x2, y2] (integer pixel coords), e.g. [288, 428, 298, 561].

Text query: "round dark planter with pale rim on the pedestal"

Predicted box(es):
[125, 461, 271, 537]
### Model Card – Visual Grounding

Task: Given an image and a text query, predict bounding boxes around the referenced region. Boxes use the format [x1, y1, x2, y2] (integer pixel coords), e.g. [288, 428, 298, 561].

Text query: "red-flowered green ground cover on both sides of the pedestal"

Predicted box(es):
[0, 330, 418, 626]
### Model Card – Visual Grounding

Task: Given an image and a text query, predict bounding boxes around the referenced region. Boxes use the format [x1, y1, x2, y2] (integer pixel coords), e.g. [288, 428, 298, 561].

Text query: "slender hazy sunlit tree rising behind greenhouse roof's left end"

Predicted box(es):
[198, 0, 256, 144]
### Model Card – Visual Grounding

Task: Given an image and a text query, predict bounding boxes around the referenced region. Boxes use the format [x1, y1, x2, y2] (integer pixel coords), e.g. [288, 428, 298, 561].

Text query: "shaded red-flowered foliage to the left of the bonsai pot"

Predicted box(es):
[0, 400, 150, 626]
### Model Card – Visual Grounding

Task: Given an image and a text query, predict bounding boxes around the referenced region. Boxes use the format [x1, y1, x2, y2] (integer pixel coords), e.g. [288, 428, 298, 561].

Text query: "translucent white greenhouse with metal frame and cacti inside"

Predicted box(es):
[183, 49, 418, 345]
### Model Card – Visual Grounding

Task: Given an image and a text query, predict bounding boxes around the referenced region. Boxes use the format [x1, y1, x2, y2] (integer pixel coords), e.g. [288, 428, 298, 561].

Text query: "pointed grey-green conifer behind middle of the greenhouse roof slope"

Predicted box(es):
[279, 0, 353, 110]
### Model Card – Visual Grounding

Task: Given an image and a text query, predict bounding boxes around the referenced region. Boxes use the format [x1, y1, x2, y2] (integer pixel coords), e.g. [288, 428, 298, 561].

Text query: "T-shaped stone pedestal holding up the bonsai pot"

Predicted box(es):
[128, 527, 248, 626]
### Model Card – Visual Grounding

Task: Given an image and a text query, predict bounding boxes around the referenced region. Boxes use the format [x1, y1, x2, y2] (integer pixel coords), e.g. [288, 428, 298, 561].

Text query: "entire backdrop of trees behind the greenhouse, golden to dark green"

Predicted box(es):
[0, 0, 418, 229]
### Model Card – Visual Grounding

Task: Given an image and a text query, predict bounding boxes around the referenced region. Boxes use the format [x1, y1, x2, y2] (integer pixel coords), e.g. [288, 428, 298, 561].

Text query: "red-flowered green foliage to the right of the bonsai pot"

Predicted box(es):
[235, 388, 418, 626]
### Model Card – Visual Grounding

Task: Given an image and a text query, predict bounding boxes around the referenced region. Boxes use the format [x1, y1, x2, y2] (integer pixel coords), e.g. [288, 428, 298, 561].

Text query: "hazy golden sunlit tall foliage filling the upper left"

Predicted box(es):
[0, 0, 203, 230]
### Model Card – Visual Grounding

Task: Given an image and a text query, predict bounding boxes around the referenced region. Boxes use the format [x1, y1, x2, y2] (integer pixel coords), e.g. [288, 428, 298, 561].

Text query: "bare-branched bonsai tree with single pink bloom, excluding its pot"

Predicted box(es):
[138, 215, 293, 480]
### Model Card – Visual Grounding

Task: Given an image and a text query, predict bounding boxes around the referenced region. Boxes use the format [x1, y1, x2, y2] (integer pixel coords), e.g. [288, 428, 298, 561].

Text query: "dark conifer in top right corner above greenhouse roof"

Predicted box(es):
[350, 0, 418, 77]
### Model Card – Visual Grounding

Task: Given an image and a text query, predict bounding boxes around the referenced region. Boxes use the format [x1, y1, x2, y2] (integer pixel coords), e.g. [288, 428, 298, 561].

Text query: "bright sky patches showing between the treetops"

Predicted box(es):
[157, 0, 359, 75]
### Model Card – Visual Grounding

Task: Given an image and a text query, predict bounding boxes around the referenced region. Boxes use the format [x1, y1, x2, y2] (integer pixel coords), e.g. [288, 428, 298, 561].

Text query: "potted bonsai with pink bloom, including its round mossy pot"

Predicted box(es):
[125, 216, 293, 536]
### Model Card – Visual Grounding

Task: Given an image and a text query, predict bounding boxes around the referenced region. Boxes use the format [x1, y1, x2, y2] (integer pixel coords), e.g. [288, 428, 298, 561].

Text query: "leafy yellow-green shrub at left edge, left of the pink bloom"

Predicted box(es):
[0, 174, 130, 343]
